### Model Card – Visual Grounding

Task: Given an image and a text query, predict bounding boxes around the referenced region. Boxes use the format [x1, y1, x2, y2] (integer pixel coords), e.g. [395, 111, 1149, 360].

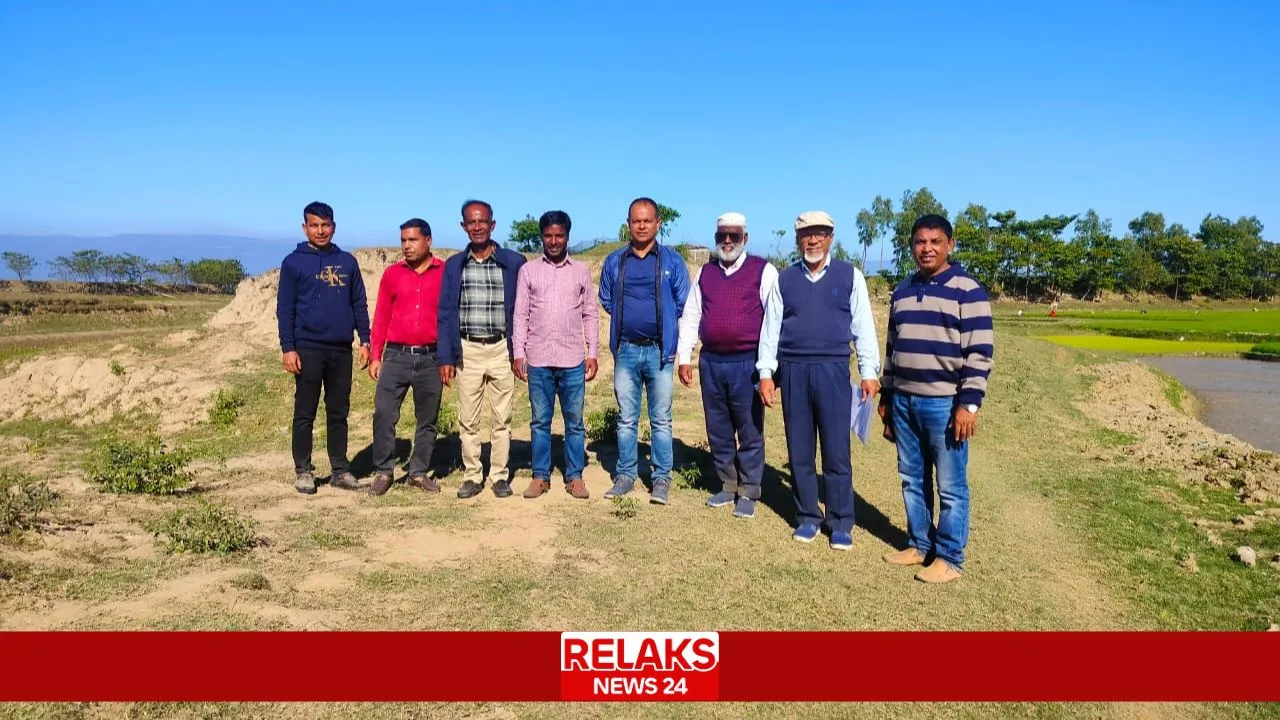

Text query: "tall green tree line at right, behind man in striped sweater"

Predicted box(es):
[855, 187, 1280, 300]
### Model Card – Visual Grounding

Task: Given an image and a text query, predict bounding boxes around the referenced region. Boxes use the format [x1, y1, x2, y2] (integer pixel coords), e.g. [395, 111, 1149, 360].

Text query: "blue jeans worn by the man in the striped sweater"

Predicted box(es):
[892, 392, 969, 568]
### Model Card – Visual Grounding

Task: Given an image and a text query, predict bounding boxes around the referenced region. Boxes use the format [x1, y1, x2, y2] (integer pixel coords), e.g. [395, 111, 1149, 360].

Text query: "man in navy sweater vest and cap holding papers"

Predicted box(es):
[760, 211, 879, 550]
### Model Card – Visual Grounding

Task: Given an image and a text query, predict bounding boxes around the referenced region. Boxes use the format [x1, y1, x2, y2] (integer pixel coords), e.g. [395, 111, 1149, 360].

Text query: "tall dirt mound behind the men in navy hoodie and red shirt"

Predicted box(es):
[206, 247, 456, 346]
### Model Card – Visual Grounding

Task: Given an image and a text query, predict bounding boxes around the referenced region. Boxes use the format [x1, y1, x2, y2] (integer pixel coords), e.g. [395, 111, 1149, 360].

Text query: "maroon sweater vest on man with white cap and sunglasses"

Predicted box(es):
[698, 255, 765, 355]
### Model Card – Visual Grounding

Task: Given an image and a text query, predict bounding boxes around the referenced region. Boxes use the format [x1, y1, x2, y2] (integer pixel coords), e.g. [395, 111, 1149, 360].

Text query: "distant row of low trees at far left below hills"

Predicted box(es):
[3, 250, 246, 292]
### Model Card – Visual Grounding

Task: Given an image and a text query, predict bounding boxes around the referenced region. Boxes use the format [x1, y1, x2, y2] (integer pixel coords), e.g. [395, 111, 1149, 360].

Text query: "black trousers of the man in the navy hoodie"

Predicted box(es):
[293, 347, 351, 474]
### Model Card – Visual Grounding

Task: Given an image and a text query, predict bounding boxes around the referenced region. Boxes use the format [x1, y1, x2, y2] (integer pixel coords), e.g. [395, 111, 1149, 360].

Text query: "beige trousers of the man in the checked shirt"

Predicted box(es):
[457, 340, 506, 483]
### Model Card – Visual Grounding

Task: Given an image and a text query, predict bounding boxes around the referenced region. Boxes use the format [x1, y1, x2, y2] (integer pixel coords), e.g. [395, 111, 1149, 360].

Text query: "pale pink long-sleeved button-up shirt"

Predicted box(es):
[512, 255, 600, 368]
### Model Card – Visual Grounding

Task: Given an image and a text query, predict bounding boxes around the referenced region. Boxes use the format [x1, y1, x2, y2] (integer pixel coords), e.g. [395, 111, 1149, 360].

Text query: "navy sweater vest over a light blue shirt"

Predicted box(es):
[778, 259, 854, 363]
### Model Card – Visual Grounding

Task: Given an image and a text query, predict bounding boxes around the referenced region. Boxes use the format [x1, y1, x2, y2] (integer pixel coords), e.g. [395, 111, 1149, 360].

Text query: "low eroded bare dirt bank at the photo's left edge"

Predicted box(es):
[0, 354, 218, 429]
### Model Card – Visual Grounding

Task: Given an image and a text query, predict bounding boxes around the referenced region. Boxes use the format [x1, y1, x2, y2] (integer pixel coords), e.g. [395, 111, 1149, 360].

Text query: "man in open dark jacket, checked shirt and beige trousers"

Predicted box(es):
[436, 200, 525, 497]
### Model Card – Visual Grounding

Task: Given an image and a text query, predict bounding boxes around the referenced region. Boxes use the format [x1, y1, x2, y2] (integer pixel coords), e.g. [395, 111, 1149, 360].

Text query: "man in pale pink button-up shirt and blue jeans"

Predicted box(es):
[511, 210, 600, 498]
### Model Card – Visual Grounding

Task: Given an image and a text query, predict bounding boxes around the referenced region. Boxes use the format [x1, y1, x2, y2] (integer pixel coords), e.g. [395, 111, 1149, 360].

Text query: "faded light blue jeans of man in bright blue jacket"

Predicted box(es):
[613, 341, 675, 483]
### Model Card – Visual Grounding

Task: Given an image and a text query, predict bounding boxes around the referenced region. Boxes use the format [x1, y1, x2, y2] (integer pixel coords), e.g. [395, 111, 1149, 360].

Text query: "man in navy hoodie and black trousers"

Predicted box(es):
[275, 202, 369, 495]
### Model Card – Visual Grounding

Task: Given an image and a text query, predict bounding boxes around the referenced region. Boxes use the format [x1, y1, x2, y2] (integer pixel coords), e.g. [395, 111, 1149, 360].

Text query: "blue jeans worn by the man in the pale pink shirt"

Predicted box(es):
[529, 365, 586, 482]
